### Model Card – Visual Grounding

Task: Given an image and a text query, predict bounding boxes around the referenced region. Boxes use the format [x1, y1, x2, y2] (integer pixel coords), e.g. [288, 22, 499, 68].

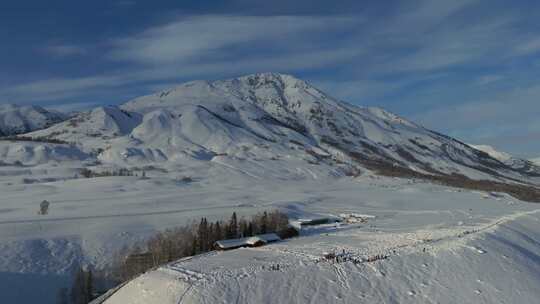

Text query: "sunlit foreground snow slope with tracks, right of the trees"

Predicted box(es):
[103, 195, 540, 304]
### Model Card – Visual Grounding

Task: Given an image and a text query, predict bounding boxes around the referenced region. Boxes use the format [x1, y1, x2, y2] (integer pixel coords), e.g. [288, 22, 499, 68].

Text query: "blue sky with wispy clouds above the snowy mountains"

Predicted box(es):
[0, 0, 540, 157]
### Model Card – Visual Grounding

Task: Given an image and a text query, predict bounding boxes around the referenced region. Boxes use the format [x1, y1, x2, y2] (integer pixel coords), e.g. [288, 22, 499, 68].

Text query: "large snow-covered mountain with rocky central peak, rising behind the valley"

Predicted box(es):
[30, 73, 531, 185]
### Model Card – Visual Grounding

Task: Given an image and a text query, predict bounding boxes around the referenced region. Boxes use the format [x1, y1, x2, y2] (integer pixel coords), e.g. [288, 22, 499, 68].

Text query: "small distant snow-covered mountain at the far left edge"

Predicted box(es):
[0, 104, 67, 136]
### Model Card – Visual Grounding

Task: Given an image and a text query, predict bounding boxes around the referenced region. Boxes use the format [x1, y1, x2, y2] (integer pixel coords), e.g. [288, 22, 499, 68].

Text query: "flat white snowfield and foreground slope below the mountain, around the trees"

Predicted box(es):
[0, 162, 540, 303]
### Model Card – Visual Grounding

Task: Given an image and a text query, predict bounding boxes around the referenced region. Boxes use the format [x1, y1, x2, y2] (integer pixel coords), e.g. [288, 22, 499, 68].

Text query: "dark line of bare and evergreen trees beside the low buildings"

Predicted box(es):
[63, 210, 298, 304]
